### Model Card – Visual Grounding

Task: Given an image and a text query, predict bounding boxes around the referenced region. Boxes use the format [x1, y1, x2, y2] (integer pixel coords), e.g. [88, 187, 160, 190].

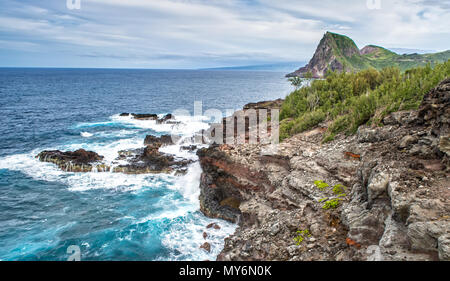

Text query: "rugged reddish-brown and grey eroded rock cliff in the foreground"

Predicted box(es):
[199, 79, 450, 260]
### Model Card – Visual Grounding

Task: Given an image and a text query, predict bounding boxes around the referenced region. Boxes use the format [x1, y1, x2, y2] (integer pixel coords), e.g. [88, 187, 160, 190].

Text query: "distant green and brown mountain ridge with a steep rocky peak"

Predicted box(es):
[286, 32, 450, 78]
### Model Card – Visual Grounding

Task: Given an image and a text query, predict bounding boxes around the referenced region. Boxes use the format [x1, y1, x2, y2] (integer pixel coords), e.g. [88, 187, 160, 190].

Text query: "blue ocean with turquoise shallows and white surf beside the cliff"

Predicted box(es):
[0, 68, 292, 260]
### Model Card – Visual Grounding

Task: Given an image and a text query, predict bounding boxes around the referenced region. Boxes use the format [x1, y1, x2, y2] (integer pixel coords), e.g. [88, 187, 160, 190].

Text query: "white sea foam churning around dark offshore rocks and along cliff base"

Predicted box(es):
[0, 110, 236, 260]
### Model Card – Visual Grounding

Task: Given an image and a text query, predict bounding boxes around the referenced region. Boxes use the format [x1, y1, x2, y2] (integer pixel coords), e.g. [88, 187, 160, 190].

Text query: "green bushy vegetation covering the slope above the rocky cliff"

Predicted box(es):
[280, 60, 450, 141]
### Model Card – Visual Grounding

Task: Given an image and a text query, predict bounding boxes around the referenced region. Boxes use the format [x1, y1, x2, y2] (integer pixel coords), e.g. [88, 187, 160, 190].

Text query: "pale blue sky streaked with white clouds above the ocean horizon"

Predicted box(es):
[0, 0, 450, 68]
